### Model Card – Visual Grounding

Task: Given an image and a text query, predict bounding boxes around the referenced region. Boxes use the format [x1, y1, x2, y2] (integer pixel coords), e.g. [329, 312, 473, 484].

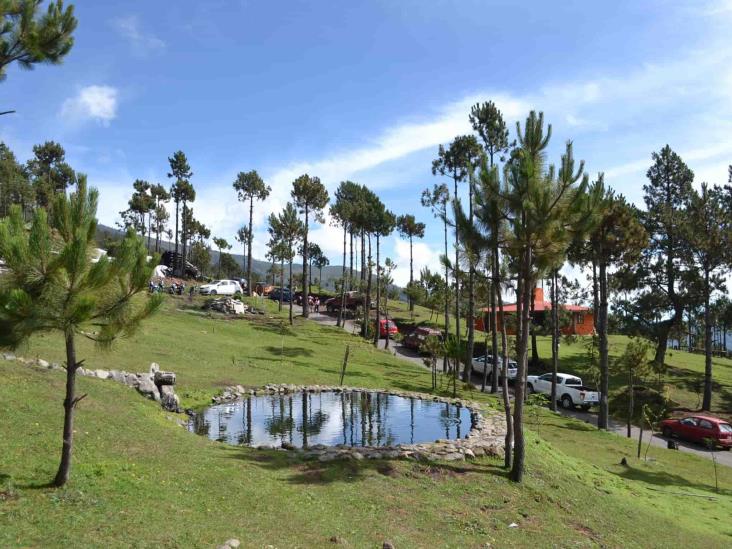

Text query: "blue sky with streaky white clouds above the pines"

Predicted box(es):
[0, 0, 732, 283]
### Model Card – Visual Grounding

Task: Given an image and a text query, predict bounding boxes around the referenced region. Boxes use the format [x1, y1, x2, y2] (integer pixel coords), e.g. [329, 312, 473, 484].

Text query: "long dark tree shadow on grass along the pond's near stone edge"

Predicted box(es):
[220, 448, 508, 485]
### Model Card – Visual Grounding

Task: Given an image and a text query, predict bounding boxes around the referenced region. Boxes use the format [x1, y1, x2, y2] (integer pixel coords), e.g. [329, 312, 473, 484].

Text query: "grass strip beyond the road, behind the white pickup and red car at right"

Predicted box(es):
[537, 335, 732, 417]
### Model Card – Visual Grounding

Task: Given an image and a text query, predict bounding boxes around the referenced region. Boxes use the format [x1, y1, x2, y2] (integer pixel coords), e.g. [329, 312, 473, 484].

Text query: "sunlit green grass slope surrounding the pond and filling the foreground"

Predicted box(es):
[0, 300, 732, 547]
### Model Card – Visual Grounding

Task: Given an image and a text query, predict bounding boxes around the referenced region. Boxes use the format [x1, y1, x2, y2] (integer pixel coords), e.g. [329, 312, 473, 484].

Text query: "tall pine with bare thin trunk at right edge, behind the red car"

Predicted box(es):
[686, 183, 732, 411]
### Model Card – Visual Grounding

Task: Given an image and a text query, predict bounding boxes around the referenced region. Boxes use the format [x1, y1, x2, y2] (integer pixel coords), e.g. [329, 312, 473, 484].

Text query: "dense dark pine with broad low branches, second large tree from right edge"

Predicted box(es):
[619, 145, 694, 365]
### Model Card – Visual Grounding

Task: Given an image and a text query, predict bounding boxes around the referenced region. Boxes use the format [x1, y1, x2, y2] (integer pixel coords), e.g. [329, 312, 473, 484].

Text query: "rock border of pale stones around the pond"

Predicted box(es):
[204, 384, 506, 462]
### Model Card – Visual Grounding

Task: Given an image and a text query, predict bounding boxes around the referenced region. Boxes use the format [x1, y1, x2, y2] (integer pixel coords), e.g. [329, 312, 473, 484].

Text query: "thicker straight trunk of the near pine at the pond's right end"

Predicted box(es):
[511, 246, 534, 482]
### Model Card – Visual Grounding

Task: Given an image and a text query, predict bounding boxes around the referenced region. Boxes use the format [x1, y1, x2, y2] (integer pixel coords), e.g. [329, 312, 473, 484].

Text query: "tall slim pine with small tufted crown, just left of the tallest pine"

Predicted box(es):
[432, 135, 481, 367]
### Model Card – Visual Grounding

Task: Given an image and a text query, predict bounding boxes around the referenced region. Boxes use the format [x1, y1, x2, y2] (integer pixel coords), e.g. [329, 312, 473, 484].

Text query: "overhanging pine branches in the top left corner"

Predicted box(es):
[0, 0, 77, 80]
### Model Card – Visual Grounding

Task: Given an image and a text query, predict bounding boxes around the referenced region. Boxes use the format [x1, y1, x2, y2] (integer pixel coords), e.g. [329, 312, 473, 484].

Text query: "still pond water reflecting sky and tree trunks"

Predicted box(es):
[188, 391, 472, 448]
